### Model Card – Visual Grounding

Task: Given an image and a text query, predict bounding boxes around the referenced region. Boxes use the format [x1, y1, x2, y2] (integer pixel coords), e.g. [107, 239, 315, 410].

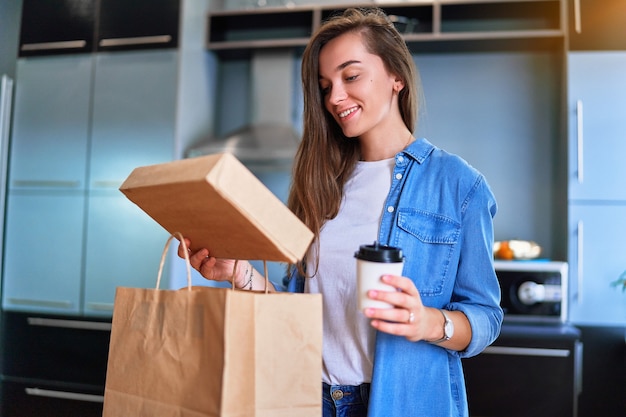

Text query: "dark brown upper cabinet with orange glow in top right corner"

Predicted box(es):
[568, 0, 626, 51]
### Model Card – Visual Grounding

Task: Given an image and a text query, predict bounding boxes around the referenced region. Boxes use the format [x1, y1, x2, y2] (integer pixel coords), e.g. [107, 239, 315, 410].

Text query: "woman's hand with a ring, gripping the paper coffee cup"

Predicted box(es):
[364, 275, 441, 342]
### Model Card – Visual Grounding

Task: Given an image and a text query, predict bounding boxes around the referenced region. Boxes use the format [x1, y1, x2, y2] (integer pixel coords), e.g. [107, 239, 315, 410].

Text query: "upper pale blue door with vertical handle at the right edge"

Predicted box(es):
[568, 51, 626, 200]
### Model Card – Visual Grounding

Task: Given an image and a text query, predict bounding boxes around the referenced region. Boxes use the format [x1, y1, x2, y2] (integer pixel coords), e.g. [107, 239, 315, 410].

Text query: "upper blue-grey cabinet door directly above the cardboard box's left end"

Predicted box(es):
[89, 50, 177, 189]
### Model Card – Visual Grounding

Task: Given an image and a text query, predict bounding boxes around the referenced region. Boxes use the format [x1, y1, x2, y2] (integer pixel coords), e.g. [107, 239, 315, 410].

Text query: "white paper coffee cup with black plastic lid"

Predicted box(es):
[354, 242, 404, 311]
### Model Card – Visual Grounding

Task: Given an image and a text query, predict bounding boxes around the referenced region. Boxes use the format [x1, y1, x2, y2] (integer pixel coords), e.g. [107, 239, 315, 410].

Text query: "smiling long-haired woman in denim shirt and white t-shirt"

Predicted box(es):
[179, 8, 502, 417]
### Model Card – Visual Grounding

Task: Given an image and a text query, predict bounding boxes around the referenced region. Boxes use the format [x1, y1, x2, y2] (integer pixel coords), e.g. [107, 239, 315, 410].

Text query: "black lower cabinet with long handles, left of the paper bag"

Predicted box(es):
[0, 313, 111, 417]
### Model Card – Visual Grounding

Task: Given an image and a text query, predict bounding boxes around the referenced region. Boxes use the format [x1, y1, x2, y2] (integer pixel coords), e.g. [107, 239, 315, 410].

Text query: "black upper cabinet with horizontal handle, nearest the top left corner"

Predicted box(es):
[19, 0, 97, 56]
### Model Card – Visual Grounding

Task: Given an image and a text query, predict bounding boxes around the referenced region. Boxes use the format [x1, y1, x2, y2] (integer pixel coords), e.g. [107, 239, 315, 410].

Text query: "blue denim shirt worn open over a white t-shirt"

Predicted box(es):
[288, 139, 503, 417]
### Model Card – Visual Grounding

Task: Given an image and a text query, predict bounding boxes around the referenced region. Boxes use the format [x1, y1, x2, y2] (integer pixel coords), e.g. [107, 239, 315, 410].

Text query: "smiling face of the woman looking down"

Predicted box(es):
[319, 33, 404, 137]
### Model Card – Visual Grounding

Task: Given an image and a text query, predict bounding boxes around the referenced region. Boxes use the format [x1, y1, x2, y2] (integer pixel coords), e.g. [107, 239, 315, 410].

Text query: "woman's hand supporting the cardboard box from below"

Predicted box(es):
[178, 238, 246, 288]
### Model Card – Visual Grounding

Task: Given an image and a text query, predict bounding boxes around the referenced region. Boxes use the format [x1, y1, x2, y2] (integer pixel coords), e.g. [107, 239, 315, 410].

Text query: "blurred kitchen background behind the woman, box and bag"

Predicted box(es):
[0, 0, 626, 417]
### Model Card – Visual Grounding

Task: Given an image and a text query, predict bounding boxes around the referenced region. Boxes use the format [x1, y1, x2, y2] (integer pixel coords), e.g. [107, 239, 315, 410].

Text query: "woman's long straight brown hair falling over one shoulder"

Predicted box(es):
[287, 7, 418, 272]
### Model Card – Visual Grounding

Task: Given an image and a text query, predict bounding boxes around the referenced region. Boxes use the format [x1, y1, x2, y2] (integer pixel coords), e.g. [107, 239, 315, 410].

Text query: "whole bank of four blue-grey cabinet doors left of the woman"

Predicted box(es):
[3, 49, 178, 316]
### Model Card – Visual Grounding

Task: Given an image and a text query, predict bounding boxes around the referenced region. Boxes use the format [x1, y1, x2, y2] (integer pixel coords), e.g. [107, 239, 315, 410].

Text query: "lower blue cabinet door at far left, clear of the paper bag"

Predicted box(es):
[2, 191, 85, 314]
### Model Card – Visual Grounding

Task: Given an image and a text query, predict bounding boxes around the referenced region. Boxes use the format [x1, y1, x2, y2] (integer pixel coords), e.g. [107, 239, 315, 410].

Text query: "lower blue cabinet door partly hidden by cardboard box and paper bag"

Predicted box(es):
[84, 191, 171, 316]
